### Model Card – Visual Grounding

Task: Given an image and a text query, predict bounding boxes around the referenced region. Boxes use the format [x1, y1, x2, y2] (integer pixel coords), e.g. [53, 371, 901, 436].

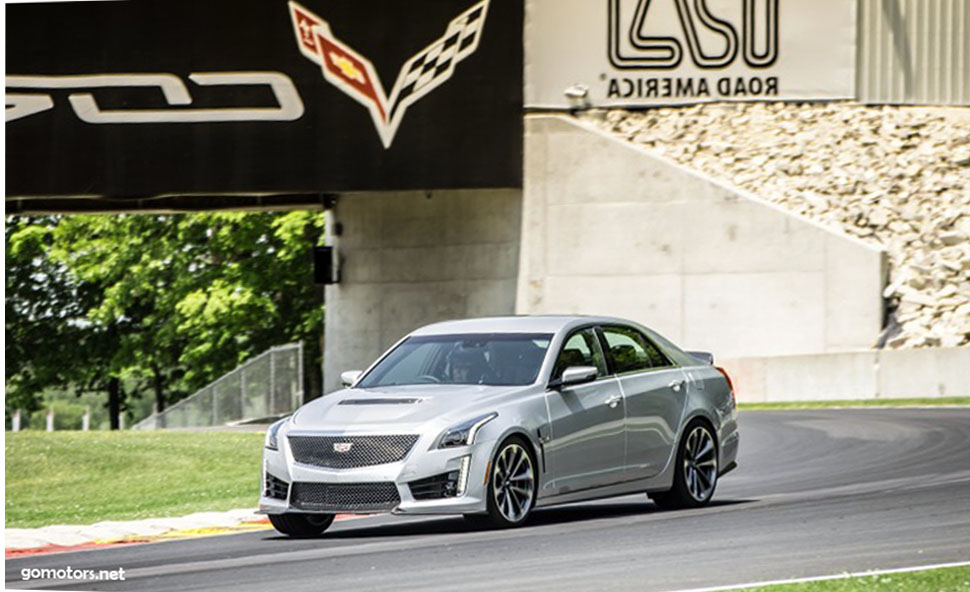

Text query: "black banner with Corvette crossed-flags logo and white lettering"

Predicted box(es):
[6, 0, 523, 198]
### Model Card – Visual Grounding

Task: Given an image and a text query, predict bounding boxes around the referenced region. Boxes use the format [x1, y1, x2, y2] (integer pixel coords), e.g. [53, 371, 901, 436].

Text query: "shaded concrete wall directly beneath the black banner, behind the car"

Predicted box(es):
[324, 190, 522, 392]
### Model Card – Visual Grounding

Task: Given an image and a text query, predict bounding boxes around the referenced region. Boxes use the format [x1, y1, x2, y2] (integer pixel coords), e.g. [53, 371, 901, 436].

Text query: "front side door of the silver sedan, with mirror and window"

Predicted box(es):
[545, 327, 626, 494]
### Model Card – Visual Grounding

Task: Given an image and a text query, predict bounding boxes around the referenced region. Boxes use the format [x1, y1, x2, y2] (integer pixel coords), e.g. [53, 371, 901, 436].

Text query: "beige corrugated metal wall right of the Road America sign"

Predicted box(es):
[856, 0, 970, 105]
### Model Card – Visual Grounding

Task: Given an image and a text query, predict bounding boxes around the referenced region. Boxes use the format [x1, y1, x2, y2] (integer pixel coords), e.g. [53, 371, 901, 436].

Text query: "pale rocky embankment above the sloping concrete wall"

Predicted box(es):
[579, 103, 970, 347]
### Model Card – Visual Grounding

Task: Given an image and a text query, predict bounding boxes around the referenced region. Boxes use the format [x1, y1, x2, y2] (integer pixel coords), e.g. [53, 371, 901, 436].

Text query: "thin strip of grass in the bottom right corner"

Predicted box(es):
[738, 566, 970, 592]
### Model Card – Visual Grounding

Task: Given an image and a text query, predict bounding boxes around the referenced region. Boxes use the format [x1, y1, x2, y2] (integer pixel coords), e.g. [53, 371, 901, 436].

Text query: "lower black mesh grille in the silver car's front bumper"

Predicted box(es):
[290, 481, 401, 512]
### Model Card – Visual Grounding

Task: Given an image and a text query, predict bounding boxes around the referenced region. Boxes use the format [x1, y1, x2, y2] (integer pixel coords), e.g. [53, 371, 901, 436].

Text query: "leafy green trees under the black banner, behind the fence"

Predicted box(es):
[6, 211, 323, 427]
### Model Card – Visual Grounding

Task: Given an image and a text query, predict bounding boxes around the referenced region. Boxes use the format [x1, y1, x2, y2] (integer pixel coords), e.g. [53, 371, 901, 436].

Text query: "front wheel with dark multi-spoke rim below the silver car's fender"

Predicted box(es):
[465, 436, 538, 528]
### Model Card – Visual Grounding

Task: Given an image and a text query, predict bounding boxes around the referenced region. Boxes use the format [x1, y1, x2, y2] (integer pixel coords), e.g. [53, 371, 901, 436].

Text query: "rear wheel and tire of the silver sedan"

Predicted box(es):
[650, 420, 718, 510]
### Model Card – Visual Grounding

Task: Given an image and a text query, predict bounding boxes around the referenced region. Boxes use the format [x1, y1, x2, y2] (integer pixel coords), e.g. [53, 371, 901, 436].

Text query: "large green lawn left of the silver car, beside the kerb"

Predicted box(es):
[5, 431, 263, 528]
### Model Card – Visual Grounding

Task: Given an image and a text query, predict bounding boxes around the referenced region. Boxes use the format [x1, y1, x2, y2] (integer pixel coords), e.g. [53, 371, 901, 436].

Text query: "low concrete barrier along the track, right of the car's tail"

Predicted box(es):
[716, 347, 970, 403]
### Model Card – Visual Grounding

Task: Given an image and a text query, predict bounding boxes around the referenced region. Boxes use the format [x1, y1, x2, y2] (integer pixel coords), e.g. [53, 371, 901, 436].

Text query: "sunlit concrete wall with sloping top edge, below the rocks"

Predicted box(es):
[516, 116, 886, 358]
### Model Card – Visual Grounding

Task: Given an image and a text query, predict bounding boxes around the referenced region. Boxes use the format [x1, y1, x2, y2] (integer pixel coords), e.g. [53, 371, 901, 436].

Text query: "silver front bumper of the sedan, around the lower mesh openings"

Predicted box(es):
[259, 437, 495, 514]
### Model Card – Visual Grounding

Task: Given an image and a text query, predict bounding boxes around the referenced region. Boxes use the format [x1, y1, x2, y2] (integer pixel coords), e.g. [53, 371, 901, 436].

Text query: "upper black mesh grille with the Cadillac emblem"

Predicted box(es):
[289, 435, 418, 469]
